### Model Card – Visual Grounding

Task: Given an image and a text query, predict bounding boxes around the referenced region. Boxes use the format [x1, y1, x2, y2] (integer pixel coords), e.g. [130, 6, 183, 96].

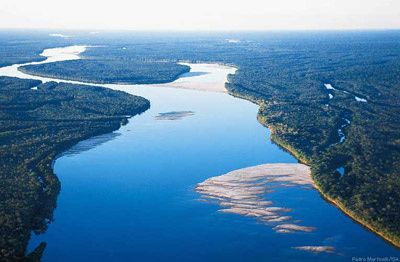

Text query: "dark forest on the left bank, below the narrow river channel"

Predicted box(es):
[0, 77, 150, 261]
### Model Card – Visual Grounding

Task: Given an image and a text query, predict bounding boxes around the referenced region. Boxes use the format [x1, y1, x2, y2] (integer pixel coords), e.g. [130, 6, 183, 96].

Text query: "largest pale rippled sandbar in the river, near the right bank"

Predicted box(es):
[196, 164, 316, 233]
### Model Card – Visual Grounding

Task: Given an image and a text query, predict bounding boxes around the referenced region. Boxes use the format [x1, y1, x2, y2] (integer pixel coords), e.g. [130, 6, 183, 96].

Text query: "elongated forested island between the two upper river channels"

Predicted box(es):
[19, 58, 190, 84]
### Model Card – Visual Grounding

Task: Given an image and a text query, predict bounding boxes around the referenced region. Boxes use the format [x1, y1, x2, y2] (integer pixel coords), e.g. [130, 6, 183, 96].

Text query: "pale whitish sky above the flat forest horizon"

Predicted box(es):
[0, 0, 400, 31]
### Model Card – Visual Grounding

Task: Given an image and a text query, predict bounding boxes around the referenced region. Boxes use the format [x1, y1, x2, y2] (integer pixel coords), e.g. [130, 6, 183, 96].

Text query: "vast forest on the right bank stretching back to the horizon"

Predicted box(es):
[19, 31, 400, 245]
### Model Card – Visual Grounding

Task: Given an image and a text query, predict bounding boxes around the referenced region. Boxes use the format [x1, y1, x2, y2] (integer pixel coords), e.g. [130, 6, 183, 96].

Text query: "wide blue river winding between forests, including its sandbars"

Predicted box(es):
[0, 46, 400, 262]
